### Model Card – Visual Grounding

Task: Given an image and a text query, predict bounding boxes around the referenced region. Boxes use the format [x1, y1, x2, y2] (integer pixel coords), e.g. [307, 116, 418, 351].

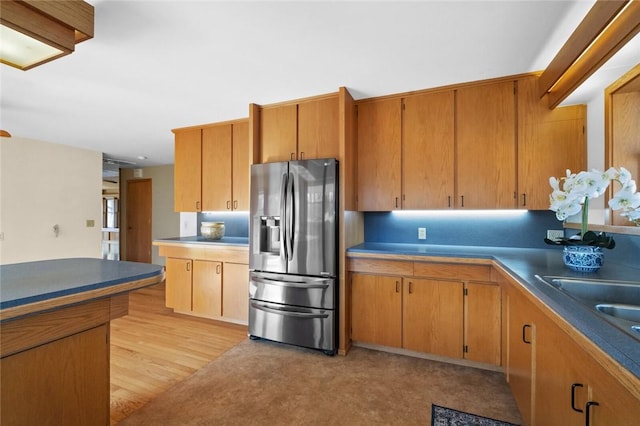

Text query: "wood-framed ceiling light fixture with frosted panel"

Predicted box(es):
[0, 0, 94, 71]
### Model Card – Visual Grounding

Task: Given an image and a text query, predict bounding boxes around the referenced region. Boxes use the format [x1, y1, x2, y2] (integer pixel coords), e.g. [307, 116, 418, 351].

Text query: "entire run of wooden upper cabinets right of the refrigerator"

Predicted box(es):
[357, 74, 586, 211]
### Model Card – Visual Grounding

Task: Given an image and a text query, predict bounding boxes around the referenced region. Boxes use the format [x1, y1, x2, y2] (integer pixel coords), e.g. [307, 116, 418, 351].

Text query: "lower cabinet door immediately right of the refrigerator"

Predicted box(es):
[351, 274, 402, 348]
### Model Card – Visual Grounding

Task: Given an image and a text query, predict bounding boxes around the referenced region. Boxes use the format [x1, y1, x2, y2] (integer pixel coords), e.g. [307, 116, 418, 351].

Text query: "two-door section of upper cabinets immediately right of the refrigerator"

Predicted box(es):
[358, 91, 454, 211]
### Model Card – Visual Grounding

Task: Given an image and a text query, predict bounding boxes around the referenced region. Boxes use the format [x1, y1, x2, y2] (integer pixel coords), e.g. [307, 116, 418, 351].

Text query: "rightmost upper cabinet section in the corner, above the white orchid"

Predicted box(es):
[517, 78, 587, 210]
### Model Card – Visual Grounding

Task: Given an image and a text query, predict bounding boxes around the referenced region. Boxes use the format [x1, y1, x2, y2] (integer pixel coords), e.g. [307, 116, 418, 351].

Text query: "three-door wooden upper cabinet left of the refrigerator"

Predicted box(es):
[174, 119, 250, 212]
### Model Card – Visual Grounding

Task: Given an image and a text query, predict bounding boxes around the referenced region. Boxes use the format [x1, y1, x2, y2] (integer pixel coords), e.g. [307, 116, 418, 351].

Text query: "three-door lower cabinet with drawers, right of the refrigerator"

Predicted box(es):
[351, 261, 501, 365]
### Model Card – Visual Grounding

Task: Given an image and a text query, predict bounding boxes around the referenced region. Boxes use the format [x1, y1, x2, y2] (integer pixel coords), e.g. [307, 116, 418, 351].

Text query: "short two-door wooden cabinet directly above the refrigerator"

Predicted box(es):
[259, 93, 340, 163]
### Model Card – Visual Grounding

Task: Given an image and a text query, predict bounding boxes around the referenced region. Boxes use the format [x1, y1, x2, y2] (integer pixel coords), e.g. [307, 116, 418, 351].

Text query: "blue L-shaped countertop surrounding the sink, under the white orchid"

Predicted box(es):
[347, 243, 640, 378]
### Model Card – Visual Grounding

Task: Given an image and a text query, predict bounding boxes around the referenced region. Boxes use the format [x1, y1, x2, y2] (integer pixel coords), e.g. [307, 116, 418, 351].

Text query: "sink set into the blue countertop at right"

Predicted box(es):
[536, 275, 640, 340]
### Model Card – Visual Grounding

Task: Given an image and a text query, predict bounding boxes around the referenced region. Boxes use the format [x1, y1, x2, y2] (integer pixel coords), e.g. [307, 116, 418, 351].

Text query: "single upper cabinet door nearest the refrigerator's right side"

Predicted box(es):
[357, 99, 402, 211]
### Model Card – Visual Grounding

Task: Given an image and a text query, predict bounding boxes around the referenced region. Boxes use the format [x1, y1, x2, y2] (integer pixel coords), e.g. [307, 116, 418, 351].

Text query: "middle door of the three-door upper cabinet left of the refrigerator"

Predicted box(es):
[202, 124, 232, 211]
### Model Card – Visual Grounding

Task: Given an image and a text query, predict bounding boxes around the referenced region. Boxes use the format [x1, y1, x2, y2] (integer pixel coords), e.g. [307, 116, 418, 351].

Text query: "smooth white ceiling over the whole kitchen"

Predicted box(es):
[0, 0, 640, 167]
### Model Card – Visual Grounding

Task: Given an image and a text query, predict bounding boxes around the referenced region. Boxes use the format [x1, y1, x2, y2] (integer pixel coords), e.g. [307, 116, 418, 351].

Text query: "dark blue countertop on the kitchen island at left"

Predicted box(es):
[0, 258, 164, 309]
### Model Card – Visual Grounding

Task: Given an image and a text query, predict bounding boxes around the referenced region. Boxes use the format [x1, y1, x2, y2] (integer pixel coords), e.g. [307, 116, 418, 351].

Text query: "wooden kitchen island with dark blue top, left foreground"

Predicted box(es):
[0, 258, 164, 425]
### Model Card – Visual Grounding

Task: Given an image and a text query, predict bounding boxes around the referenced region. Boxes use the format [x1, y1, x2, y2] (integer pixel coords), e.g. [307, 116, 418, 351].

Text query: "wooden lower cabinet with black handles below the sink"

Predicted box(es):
[505, 272, 640, 426]
